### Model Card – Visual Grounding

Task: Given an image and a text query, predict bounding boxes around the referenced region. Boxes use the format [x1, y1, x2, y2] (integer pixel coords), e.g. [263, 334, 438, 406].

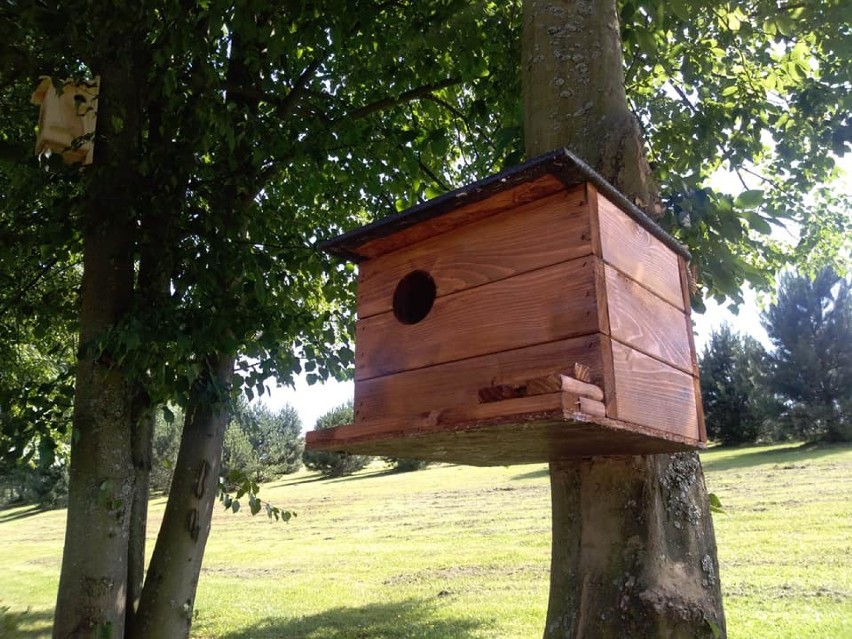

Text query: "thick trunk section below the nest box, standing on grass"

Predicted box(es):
[544, 453, 725, 639]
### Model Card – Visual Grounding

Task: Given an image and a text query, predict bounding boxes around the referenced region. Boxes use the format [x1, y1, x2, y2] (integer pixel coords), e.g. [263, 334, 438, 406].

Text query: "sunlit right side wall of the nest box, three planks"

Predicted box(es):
[589, 186, 706, 441]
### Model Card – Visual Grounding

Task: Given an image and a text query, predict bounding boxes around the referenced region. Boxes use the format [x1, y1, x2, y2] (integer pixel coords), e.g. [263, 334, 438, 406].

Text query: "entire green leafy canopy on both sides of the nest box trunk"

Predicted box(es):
[0, 0, 852, 452]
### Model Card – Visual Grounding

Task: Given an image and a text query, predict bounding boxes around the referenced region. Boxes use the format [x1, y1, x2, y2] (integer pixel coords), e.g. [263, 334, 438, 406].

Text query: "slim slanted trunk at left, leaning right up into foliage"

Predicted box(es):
[127, 355, 234, 639]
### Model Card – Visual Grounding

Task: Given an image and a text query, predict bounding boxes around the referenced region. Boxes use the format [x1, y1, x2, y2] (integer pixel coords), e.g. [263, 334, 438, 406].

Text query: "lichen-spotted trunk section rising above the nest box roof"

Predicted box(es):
[521, 0, 661, 217]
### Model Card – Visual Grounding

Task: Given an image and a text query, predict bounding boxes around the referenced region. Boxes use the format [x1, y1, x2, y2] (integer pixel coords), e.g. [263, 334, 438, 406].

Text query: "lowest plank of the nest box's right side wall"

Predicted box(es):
[608, 340, 699, 440]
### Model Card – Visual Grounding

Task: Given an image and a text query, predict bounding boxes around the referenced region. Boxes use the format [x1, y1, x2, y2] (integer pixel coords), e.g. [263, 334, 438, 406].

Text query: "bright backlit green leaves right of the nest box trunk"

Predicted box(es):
[620, 0, 852, 302]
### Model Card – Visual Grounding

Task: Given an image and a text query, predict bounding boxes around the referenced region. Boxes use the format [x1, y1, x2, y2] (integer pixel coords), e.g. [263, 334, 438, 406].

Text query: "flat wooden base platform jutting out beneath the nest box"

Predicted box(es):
[306, 392, 703, 466]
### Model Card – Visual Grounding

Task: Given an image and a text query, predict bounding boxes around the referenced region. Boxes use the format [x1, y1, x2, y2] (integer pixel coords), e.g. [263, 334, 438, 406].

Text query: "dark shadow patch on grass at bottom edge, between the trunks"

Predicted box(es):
[220, 600, 490, 639]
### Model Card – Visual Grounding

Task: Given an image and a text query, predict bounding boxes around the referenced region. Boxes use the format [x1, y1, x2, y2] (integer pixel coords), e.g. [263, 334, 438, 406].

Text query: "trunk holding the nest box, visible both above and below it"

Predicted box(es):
[522, 0, 725, 639]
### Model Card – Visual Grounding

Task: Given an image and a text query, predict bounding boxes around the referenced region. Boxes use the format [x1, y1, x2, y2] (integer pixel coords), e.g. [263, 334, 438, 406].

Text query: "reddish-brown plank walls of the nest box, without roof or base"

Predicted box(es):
[355, 181, 703, 440]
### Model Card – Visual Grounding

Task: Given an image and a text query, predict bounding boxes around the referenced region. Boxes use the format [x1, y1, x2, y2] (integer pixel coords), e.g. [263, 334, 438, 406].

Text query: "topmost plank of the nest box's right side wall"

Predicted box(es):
[597, 195, 684, 310]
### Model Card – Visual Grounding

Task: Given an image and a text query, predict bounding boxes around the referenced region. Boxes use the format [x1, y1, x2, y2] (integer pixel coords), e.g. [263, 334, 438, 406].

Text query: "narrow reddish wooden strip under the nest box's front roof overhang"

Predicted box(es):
[358, 175, 565, 258]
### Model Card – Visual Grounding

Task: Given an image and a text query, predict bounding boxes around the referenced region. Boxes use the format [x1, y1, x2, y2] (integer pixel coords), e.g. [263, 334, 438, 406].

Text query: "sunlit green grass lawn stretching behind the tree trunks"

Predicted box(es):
[0, 445, 852, 639]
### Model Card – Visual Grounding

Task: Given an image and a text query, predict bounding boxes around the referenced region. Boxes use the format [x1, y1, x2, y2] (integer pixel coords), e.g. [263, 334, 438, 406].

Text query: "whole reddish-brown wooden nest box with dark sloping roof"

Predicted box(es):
[307, 150, 706, 465]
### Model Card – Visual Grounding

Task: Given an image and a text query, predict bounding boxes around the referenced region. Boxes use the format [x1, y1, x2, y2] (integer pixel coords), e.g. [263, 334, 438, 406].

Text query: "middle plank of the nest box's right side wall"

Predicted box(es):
[605, 265, 693, 374]
